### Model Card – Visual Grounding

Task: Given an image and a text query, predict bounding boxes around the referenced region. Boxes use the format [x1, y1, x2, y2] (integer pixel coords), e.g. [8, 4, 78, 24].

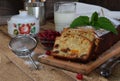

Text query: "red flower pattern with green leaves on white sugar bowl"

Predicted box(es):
[13, 23, 36, 35]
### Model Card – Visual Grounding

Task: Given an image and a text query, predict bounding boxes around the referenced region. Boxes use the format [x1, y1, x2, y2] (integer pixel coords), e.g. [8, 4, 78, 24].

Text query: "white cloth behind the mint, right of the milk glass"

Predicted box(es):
[76, 2, 120, 26]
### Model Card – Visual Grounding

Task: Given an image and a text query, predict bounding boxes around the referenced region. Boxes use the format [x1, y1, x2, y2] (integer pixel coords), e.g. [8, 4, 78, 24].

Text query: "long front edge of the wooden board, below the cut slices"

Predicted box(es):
[39, 56, 87, 74]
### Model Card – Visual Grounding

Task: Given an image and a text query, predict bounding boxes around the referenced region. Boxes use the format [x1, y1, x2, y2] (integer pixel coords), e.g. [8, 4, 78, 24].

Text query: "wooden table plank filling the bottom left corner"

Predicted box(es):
[0, 53, 33, 81]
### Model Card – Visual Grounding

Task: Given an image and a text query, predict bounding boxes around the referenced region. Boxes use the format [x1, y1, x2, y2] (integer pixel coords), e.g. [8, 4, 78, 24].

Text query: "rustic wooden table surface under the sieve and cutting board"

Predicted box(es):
[0, 22, 120, 81]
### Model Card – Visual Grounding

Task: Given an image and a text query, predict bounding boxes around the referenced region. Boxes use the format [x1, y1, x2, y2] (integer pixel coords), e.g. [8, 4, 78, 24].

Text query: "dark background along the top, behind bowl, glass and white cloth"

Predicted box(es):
[0, 0, 120, 18]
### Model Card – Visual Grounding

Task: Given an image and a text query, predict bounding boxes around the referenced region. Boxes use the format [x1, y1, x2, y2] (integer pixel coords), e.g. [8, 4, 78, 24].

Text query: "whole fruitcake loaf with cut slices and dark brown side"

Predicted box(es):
[52, 26, 120, 62]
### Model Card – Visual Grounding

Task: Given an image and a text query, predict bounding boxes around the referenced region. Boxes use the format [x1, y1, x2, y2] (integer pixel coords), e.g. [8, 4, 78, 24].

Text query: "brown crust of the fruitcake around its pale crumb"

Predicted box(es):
[52, 26, 120, 62]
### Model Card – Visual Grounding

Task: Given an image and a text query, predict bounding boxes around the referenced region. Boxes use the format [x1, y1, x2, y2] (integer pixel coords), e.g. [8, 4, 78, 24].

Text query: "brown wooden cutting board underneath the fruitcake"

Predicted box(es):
[39, 41, 120, 74]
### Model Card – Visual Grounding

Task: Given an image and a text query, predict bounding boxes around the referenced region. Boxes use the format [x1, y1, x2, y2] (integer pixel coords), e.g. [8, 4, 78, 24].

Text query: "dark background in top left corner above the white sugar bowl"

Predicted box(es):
[0, 0, 24, 16]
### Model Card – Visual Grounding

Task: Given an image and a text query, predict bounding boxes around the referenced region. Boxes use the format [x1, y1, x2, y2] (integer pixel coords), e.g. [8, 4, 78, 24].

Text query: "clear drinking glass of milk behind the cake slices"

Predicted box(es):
[54, 2, 76, 32]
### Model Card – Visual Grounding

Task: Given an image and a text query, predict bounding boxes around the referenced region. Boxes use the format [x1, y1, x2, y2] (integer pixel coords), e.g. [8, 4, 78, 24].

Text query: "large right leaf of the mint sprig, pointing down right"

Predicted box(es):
[97, 17, 118, 34]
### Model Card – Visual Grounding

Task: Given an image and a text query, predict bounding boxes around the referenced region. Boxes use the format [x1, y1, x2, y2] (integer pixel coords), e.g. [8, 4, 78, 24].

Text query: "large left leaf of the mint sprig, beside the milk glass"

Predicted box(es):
[70, 16, 89, 28]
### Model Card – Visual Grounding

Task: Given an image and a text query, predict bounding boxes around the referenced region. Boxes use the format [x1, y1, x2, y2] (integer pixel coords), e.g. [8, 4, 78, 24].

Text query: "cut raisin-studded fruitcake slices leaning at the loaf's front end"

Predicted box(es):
[52, 28, 95, 61]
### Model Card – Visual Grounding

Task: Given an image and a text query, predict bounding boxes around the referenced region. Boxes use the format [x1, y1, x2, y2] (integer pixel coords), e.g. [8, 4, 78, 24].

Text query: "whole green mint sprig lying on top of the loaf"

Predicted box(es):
[70, 12, 118, 34]
